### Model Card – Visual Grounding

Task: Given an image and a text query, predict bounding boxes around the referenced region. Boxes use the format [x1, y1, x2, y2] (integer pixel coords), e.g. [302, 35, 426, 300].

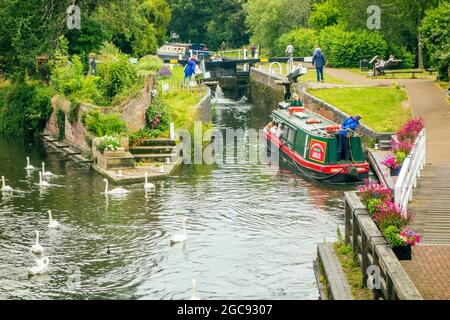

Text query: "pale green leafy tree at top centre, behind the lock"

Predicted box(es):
[244, 0, 311, 49]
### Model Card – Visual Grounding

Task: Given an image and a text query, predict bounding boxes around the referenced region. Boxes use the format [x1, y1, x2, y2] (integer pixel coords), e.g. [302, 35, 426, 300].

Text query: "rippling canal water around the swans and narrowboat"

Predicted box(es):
[0, 95, 355, 299]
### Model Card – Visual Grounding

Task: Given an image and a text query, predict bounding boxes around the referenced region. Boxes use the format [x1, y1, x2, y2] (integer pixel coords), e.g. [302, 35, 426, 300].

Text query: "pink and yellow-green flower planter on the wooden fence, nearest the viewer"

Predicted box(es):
[358, 180, 420, 260]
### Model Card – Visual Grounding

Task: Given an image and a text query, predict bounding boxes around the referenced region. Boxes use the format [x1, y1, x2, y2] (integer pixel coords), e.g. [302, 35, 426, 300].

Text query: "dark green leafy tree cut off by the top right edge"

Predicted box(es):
[420, 2, 450, 81]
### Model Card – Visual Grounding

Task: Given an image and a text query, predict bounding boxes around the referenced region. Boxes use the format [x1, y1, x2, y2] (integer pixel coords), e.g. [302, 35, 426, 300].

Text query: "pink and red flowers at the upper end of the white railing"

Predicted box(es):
[381, 118, 424, 176]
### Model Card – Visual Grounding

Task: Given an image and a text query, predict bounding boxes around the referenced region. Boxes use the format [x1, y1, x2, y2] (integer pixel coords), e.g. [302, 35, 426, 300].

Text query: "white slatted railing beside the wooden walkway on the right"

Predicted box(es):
[394, 129, 426, 209]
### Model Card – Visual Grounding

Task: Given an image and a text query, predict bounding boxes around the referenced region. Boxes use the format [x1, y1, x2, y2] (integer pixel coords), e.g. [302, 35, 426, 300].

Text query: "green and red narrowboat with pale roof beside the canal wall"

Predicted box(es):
[264, 102, 369, 184]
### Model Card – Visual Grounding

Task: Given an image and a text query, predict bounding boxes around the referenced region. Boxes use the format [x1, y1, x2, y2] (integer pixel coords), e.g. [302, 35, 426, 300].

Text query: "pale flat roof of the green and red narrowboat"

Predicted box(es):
[273, 108, 346, 138]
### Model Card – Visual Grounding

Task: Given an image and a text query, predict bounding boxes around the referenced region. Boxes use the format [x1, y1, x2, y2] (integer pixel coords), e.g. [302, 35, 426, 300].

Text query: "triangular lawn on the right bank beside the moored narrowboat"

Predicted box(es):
[308, 87, 411, 132]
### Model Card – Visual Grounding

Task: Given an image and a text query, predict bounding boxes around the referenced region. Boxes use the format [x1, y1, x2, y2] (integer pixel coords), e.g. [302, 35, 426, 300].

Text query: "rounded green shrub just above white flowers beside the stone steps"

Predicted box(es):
[83, 111, 127, 137]
